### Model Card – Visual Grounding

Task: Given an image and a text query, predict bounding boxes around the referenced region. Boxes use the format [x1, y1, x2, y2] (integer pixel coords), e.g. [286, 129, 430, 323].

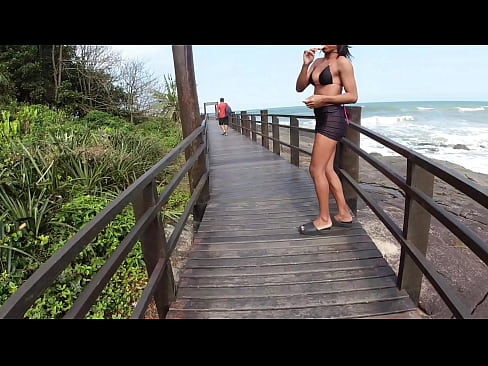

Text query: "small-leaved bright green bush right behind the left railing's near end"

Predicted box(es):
[25, 195, 147, 319]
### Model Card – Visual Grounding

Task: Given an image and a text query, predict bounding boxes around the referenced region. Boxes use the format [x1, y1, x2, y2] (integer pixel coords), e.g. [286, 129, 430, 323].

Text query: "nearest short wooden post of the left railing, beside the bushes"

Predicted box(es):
[133, 181, 176, 319]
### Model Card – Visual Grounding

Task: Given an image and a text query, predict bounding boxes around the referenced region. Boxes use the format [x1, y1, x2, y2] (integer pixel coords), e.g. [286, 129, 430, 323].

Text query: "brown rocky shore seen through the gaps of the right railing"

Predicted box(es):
[274, 128, 488, 318]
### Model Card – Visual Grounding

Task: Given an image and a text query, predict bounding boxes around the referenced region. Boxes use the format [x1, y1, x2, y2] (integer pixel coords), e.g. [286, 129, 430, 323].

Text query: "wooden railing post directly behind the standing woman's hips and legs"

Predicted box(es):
[337, 106, 361, 215]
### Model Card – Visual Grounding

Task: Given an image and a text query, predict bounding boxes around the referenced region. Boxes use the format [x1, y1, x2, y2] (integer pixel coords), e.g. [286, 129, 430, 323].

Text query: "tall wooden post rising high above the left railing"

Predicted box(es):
[173, 45, 210, 227]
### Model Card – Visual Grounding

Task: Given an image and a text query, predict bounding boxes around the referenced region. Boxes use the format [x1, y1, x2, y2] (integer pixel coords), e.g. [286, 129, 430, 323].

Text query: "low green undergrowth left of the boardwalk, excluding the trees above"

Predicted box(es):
[0, 105, 189, 318]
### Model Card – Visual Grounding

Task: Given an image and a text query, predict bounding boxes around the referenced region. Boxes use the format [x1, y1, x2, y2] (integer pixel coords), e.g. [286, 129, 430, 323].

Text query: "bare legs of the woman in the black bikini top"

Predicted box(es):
[309, 133, 352, 230]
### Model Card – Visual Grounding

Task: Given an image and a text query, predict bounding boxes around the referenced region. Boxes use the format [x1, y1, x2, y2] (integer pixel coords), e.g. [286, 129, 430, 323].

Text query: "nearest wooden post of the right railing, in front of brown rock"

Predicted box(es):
[398, 159, 434, 304]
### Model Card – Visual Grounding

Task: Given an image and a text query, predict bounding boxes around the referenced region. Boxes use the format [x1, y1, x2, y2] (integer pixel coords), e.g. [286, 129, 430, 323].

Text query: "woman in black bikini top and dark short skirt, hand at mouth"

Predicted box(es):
[296, 45, 358, 235]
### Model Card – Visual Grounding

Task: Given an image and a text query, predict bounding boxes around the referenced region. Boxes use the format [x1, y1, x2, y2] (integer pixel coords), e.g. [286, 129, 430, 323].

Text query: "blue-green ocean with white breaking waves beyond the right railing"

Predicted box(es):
[247, 101, 488, 174]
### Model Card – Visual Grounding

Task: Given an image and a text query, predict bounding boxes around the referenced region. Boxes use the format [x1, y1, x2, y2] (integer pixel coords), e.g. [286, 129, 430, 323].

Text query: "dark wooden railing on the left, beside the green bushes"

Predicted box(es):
[0, 120, 208, 319]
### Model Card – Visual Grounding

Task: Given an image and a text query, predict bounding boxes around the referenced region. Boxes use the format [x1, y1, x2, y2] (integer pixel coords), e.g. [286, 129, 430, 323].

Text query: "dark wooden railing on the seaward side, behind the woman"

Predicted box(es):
[230, 106, 488, 318]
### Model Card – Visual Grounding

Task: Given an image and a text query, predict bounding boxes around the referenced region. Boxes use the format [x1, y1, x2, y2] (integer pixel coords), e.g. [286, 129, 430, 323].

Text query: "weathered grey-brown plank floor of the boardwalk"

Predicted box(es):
[166, 120, 421, 319]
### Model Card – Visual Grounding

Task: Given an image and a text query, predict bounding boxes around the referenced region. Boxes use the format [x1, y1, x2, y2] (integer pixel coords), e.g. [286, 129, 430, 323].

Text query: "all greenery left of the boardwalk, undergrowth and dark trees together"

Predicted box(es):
[0, 45, 189, 318]
